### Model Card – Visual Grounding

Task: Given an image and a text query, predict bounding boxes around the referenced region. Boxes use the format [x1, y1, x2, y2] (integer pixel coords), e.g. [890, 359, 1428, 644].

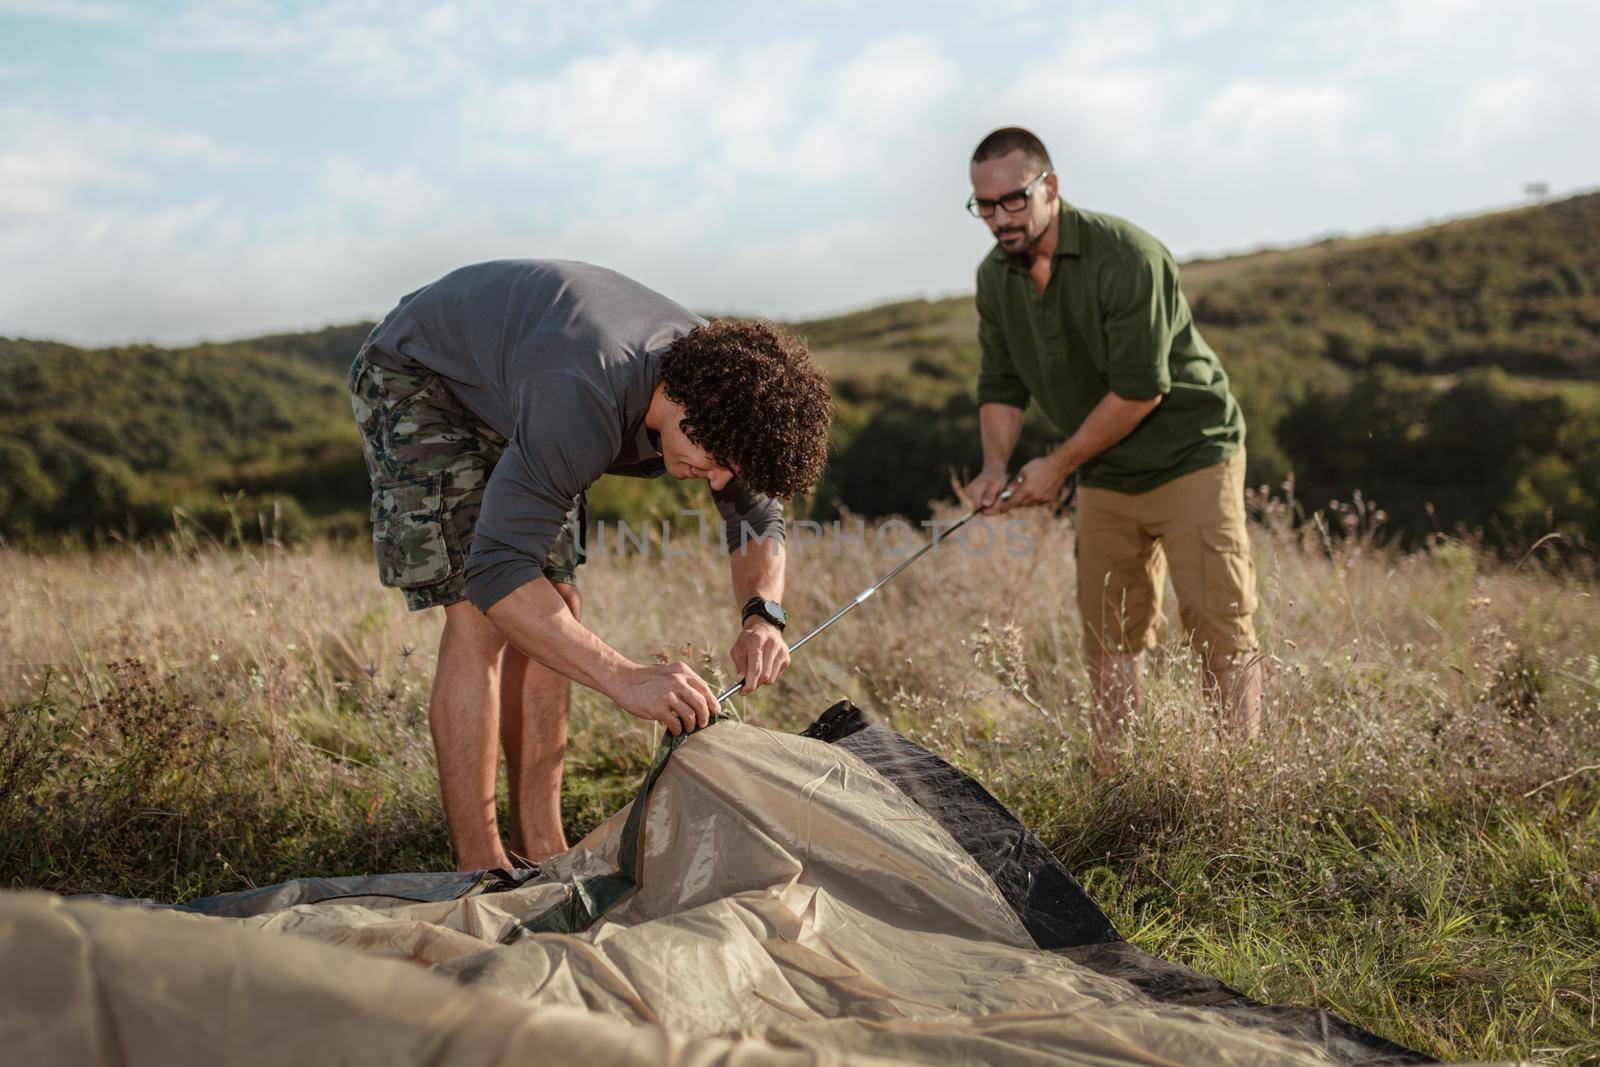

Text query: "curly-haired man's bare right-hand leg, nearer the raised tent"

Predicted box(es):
[501, 582, 581, 862]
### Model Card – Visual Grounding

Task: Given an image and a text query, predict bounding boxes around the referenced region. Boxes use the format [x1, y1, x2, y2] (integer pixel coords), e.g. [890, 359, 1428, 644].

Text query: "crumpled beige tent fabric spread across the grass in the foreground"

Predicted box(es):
[0, 723, 1395, 1067]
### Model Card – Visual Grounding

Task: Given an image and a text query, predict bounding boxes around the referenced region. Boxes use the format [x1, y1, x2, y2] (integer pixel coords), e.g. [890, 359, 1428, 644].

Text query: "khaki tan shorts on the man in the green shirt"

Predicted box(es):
[1077, 450, 1256, 654]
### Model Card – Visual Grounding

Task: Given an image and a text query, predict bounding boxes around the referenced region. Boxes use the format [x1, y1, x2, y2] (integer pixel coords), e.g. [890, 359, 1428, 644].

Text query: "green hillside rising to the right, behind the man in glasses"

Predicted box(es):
[802, 194, 1600, 545]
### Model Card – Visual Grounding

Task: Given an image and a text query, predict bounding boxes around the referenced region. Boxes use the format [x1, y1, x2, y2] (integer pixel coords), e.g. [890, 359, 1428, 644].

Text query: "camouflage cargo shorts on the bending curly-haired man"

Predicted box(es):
[349, 346, 584, 611]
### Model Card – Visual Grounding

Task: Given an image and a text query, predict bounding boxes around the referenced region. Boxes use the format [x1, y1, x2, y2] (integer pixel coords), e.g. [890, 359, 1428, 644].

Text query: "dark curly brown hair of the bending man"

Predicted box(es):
[661, 318, 834, 496]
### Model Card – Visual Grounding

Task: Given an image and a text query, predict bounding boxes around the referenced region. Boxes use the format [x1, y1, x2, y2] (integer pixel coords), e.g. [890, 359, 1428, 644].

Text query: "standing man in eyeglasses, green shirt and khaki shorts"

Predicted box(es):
[966, 126, 1261, 773]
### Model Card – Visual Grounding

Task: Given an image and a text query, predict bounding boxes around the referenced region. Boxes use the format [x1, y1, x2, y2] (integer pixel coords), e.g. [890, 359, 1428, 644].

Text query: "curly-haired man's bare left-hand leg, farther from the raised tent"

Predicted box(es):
[427, 600, 510, 870]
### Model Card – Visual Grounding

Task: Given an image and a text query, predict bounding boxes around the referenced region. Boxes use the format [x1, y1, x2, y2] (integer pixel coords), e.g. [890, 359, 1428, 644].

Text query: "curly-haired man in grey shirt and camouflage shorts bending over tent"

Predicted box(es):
[349, 259, 830, 870]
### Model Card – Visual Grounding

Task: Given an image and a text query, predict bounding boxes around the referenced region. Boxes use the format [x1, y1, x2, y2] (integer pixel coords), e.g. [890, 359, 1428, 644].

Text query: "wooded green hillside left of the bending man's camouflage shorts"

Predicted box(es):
[0, 341, 360, 539]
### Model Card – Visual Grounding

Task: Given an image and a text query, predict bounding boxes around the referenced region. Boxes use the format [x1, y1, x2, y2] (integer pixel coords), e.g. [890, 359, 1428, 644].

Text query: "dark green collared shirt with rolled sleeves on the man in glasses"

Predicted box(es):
[978, 202, 1245, 493]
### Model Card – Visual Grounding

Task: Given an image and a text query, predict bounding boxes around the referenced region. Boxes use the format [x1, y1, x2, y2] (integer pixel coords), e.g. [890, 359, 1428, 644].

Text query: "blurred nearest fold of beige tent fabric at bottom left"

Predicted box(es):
[0, 893, 851, 1067]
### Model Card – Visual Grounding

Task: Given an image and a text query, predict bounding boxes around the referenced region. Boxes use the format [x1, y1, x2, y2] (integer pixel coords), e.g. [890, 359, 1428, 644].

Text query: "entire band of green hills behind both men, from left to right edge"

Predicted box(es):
[0, 195, 1600, 545]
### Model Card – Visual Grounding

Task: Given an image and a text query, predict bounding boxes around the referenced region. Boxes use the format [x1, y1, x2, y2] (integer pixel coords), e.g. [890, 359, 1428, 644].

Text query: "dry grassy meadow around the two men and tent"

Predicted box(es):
[0, 501, 1600, 1062]
